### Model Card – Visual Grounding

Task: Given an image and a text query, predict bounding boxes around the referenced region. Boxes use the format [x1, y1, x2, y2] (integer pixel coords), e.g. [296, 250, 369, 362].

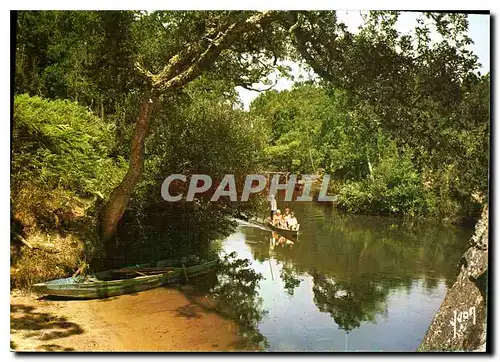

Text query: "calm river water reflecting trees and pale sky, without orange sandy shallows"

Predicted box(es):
[216, 202, 472, 351]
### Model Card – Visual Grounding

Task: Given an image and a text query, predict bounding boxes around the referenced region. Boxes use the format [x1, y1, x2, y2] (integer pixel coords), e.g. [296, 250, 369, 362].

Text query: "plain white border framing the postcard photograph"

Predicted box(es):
[0, 0, 500, 360]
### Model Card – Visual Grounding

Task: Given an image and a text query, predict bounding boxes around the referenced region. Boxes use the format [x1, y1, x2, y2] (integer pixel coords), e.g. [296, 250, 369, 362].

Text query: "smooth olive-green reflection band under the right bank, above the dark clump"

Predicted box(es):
[276, 203, 469, 291]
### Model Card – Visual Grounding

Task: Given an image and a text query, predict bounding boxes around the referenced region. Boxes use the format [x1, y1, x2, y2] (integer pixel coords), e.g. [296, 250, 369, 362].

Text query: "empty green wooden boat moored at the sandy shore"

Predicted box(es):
[33, 260, 218, 299]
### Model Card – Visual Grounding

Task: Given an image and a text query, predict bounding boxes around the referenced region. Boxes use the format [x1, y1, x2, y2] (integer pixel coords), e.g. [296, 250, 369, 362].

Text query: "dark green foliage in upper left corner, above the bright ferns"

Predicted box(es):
[15, 11, 137, 116]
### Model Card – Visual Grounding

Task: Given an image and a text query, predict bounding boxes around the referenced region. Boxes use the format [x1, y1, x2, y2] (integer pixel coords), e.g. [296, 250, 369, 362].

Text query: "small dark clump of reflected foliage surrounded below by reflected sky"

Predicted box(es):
[313, 273, 389, 331]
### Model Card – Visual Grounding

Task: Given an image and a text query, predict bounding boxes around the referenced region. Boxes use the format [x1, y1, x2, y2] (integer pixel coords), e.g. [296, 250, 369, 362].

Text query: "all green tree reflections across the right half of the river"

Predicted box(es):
[240, 203, 469, 331]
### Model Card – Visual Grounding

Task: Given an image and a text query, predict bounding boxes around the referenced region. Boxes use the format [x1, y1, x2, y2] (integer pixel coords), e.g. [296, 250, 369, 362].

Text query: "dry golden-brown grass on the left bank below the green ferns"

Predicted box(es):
[11, 183, 98, 290]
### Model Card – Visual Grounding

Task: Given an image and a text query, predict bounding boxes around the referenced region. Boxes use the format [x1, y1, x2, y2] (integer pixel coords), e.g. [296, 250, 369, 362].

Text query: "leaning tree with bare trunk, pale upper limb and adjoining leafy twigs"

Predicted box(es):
[98, 12, 292, 250]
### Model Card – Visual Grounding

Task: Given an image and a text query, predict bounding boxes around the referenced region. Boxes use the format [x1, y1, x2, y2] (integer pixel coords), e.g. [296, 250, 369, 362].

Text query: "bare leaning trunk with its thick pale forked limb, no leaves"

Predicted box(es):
[96, 11, 278, 259]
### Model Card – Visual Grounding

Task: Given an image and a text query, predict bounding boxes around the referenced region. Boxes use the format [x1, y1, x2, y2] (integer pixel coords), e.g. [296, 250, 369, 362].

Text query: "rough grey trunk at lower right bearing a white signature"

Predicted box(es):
[418, 206, 488, 351]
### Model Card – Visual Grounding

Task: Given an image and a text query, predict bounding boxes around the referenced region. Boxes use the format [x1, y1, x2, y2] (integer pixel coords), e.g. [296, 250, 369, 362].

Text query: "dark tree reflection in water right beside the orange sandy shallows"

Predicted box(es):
[209, 252, 268, 346]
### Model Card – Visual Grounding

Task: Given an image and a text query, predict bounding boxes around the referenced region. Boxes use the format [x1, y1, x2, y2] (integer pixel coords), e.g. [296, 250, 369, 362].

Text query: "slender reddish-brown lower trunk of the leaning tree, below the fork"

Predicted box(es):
[101, 92, 151, 253]
